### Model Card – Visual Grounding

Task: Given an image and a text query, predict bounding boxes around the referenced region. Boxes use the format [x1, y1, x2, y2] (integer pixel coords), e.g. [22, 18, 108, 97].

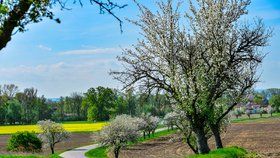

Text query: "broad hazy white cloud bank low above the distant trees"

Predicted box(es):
[0, 58, 121, 97]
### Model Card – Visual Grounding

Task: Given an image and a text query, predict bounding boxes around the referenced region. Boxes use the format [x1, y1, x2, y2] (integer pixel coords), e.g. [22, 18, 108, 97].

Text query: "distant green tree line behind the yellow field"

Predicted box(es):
[0, 84, 170, 124]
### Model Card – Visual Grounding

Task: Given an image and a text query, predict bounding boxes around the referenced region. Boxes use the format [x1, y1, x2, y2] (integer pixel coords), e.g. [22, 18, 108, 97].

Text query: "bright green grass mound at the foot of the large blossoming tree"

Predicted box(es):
[187, 147, 248, 158]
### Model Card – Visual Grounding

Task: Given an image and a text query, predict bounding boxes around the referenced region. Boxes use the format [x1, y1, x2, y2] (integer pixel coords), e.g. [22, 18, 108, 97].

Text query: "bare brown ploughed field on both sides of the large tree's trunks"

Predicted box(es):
[120, 120, 280, 158]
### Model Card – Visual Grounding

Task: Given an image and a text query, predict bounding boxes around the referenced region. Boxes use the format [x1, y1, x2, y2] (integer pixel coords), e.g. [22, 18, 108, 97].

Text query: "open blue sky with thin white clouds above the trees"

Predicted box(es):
[0, 0, 280, 97]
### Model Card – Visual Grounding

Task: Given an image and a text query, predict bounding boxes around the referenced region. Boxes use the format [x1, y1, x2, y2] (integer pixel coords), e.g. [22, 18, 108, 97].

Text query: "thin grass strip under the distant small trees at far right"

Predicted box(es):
[231, 113, 280, 123]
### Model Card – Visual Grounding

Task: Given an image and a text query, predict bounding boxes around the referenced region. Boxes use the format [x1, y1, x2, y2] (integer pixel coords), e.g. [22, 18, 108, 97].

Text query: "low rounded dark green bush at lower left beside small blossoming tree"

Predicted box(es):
[7, 131, 42, 152]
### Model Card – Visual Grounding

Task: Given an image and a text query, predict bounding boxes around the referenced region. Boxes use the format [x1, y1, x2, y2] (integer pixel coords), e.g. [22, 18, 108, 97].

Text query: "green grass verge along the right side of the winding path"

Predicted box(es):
[85, 130, 176, 158]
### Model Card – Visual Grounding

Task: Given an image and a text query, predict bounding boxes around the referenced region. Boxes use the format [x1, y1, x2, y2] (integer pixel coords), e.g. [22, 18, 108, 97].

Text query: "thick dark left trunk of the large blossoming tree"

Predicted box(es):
[194, 127, 210, 154]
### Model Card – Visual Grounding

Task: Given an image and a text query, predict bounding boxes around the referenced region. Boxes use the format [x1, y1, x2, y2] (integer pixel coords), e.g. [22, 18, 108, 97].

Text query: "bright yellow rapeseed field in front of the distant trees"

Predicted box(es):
[0, 122, 107, 134]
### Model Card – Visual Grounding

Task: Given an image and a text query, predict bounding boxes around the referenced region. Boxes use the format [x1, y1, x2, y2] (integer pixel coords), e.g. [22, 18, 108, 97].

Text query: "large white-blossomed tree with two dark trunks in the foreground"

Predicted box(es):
[112, 0, 271, 153]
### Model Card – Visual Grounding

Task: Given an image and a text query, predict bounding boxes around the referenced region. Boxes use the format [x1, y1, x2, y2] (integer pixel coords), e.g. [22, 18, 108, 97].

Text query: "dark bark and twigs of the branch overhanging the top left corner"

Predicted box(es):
[0, 0, 127, 50]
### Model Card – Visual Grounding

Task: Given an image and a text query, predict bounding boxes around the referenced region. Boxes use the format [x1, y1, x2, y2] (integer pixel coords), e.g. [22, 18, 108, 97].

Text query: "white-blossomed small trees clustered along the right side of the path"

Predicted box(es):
[98, 114, 159, 158]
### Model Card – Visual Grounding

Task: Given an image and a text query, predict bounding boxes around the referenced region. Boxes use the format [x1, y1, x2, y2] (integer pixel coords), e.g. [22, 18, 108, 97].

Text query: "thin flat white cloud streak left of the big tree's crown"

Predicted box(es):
[59, 48, 122, 55]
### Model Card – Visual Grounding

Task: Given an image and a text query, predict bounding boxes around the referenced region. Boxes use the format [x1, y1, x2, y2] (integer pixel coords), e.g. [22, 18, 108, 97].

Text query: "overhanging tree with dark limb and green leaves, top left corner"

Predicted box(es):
[0, 0, 127, 50]
